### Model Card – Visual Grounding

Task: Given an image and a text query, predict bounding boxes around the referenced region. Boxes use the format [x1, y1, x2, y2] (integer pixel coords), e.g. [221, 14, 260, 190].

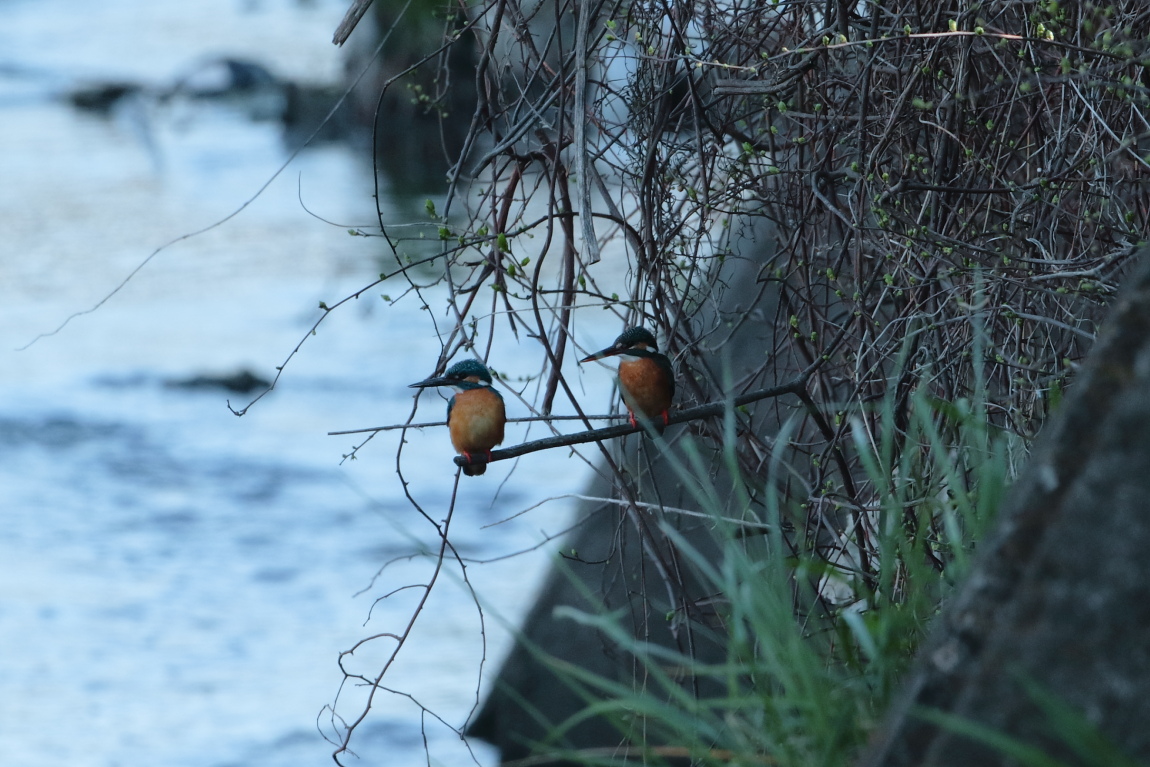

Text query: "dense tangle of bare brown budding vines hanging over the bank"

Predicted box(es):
[319, 0, 1150, 763]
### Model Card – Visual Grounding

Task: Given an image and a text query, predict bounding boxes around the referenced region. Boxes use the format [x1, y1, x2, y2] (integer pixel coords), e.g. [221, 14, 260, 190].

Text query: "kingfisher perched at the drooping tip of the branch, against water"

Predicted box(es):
[409, 360, 507, 477]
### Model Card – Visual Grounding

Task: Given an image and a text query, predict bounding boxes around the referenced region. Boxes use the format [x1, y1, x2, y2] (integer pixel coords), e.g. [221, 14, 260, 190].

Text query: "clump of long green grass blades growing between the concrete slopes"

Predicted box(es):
[554, 381, 1025, 767]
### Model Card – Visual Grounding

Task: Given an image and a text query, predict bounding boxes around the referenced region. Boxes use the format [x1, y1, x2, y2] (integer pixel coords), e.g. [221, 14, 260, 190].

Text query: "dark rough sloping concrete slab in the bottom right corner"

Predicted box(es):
[861, 251, 1150, 767]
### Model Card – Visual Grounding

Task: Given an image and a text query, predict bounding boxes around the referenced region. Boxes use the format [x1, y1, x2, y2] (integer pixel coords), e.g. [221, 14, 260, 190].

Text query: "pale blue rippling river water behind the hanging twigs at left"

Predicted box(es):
[0, 0, 601, 767]
